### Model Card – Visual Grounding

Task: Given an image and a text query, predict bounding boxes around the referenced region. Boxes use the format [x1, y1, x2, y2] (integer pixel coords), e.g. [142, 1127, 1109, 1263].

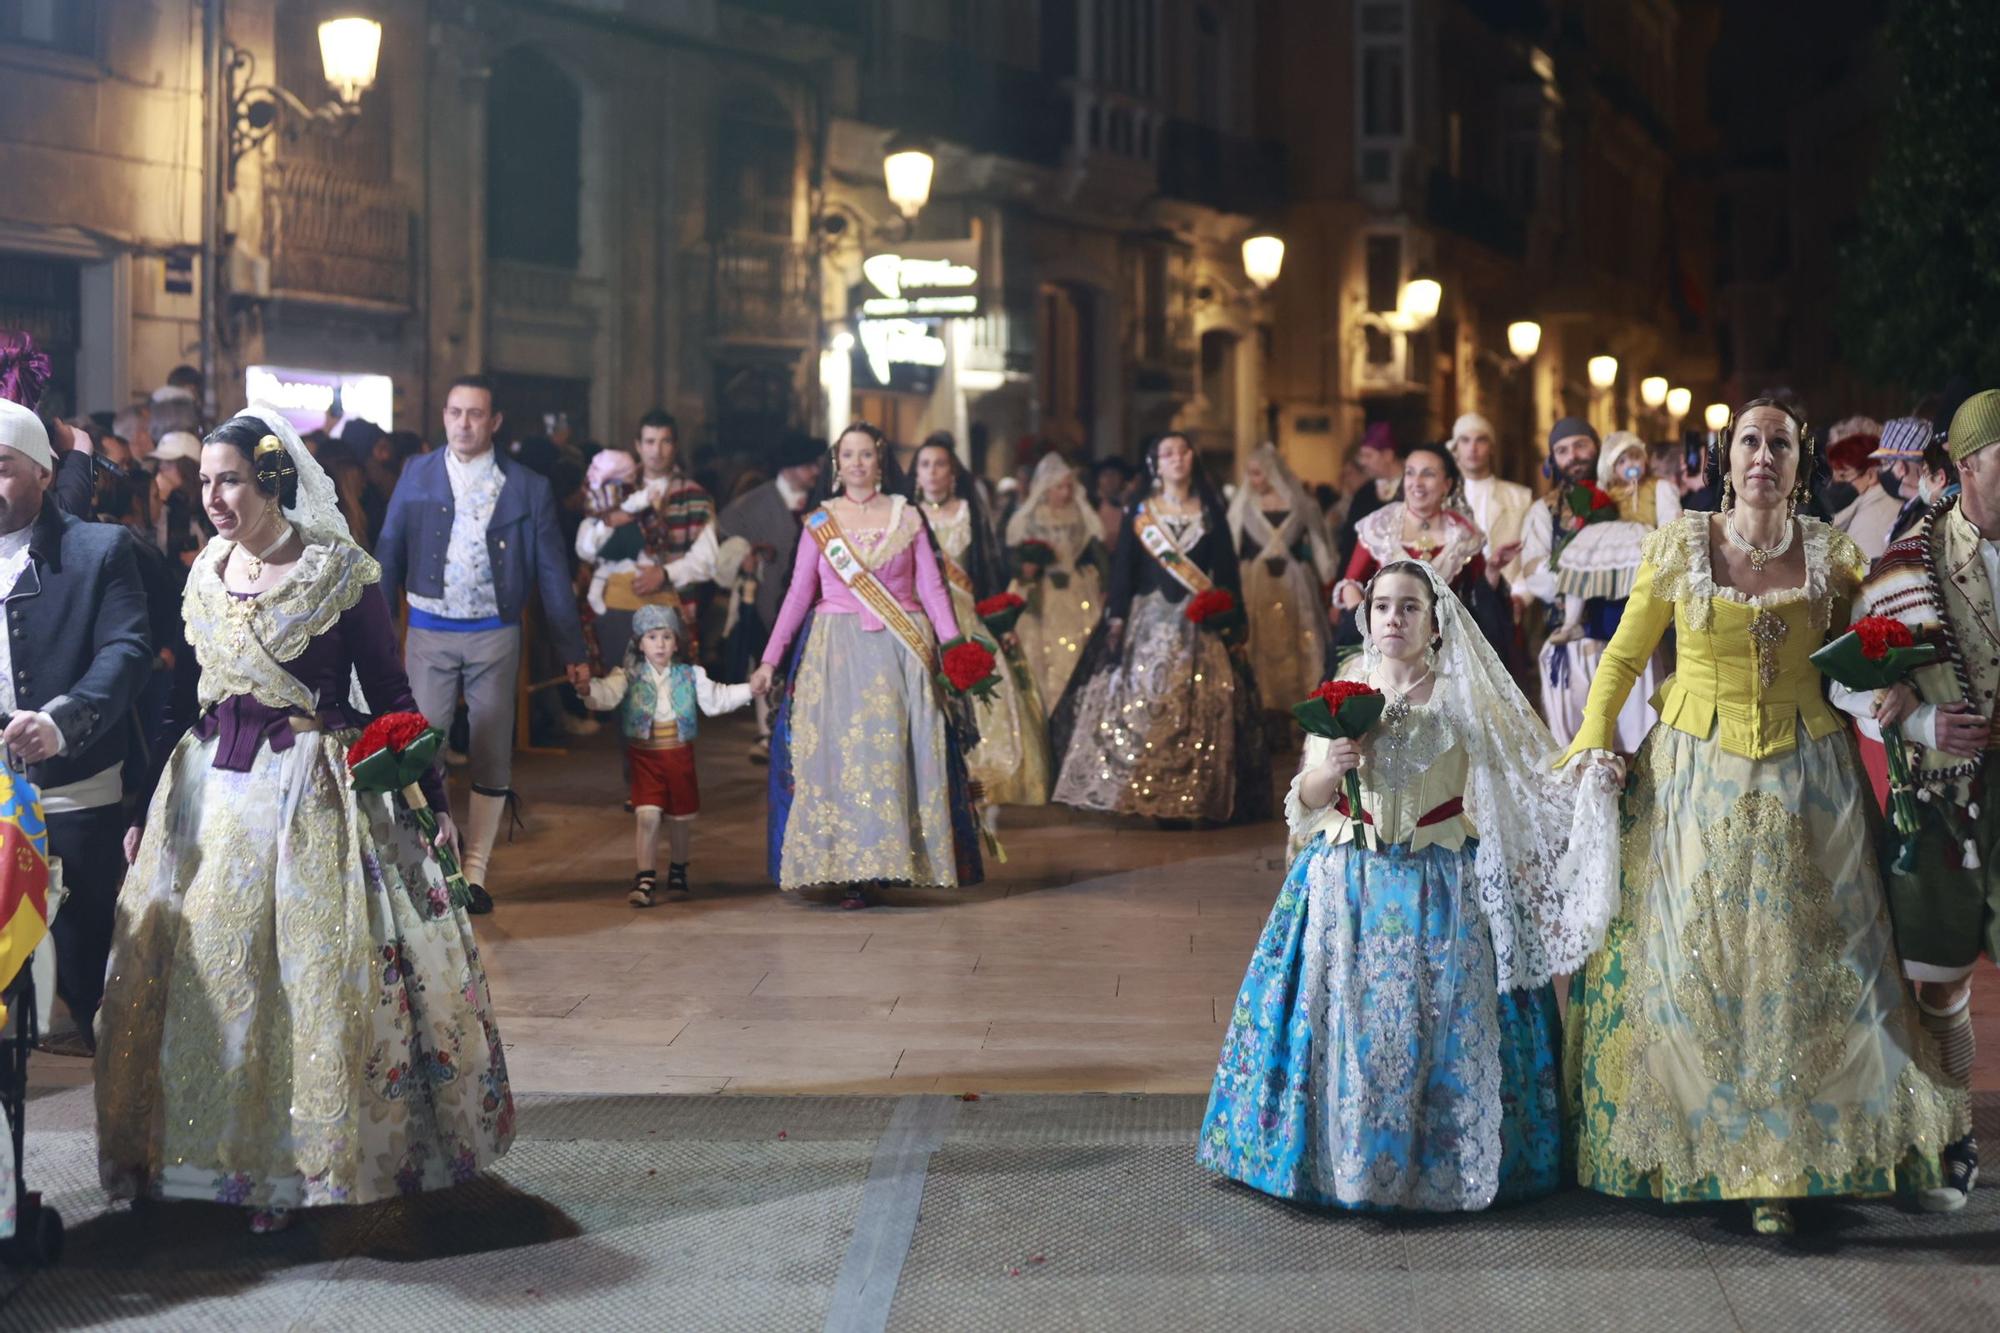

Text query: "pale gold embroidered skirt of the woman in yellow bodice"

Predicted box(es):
[1564, 727, 1970, 1201]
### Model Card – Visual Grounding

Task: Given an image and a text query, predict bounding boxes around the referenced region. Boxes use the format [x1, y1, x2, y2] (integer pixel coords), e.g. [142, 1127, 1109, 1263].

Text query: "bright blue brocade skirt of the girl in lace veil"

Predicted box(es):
[1198, 839, 1562, 1211]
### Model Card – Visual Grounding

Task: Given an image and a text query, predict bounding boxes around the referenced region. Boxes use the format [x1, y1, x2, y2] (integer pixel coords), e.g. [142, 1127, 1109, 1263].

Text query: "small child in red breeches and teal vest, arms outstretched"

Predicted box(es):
[586, 606, 750, 907]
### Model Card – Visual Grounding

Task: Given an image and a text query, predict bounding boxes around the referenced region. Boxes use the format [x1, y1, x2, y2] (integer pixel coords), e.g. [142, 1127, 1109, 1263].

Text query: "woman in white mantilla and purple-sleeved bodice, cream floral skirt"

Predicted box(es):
[96, 406, 514, 1231]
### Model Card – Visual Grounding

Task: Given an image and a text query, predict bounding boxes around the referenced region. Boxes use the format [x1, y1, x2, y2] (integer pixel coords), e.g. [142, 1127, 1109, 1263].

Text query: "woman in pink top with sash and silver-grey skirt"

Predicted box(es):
[750, 424, 982, 907]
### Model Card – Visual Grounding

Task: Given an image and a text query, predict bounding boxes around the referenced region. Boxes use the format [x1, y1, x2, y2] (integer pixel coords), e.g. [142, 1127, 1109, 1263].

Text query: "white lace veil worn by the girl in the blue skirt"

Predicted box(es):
[1362, 560, 1618, 991]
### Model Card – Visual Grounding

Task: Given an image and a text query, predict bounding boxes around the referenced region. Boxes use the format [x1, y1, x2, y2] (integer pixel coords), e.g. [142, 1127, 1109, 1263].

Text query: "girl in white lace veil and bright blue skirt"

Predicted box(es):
[1200, 560, 1616, 1211]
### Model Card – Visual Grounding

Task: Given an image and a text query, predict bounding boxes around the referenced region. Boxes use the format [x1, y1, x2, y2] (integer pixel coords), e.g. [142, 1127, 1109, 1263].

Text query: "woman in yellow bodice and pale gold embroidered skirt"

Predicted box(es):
[1564, 398, 1970, 1233]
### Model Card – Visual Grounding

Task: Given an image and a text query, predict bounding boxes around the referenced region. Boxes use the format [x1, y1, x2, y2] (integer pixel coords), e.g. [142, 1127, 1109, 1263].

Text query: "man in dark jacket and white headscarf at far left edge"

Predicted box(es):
[0, 400, 152, 1049]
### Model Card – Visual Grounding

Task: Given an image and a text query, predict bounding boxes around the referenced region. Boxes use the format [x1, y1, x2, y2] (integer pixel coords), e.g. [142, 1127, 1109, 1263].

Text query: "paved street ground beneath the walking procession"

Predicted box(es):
[0, 725, 2000, 1333]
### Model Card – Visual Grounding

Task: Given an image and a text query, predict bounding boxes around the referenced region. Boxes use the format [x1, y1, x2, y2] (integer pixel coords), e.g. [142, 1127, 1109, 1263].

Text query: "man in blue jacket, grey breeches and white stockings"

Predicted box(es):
[376, 374, 590, 913]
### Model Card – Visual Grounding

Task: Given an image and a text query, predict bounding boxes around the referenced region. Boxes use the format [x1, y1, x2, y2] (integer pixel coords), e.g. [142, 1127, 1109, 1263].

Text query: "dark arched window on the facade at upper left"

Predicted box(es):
[486, 46, 584, 268]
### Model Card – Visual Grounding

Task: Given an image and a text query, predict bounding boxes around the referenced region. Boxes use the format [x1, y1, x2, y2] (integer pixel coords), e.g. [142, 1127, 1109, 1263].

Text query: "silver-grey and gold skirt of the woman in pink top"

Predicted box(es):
[772, 612, 960, 889]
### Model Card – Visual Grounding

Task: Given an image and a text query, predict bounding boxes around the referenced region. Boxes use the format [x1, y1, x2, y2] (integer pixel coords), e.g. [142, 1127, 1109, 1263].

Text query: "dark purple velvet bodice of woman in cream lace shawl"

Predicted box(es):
[194, 588, 450, 813]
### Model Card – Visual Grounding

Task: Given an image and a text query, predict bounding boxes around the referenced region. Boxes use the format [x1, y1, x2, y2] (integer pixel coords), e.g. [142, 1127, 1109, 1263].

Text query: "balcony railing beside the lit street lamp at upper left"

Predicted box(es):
[264, 160, 414, 310]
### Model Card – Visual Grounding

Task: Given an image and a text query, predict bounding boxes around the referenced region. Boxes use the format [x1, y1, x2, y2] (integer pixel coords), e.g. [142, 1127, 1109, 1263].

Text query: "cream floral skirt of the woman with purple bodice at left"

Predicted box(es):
[96, 733, 514, 1207]
